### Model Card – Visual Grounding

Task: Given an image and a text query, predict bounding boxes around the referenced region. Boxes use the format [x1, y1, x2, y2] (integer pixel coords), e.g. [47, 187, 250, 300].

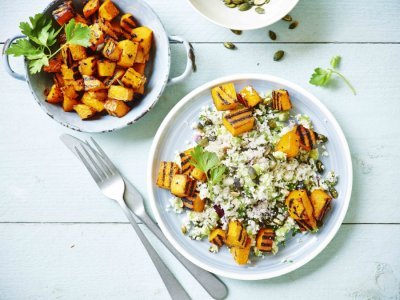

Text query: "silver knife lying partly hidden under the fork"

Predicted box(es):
[60, 134, 228, 299]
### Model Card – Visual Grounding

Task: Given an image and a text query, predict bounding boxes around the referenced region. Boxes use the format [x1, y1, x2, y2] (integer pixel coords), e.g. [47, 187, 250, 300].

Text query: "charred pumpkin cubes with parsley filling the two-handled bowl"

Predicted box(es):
[7, 0, 153, 120]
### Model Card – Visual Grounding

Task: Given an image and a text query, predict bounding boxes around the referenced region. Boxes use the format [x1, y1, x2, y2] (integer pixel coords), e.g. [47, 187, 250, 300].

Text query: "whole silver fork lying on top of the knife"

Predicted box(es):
[75, 140, 190, 299]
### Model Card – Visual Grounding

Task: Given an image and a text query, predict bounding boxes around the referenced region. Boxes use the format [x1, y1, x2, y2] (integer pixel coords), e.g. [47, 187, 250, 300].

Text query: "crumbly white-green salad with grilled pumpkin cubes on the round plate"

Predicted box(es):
[157, 83, 338, 265]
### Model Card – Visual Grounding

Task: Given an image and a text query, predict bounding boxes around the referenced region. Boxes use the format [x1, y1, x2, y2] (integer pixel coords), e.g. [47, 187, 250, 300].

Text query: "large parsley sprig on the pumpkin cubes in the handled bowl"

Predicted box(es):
[6, 13, 90, 74]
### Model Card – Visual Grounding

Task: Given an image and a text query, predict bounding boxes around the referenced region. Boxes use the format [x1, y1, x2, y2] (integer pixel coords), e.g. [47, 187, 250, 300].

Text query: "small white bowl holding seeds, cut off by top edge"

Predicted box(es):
[188, 0, 299, 30]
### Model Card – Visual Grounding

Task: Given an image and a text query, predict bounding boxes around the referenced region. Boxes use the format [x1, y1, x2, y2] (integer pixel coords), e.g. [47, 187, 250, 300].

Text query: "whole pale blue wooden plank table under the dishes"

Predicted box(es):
[0, 0, 400, 299]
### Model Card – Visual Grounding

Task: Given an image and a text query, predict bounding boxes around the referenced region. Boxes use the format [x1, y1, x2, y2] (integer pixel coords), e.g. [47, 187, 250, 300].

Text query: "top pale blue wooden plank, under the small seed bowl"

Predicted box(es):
[0, 0, 400, 42]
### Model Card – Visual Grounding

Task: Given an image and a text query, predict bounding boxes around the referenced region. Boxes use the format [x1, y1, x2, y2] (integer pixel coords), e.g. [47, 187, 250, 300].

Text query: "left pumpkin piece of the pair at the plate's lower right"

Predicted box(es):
[285, 190, 317, 230]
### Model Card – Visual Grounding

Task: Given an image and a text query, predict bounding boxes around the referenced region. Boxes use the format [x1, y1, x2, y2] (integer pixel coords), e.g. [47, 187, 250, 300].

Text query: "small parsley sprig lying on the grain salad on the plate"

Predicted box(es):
[190, 146, 226, 185]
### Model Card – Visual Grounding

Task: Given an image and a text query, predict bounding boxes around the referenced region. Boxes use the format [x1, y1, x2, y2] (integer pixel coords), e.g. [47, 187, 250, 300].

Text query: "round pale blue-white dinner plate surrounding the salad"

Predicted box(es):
[147, 74, 353, 280]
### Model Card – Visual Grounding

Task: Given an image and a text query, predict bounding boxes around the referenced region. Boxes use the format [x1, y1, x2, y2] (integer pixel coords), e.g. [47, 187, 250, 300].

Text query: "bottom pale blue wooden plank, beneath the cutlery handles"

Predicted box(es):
[0, 224, 400, 300]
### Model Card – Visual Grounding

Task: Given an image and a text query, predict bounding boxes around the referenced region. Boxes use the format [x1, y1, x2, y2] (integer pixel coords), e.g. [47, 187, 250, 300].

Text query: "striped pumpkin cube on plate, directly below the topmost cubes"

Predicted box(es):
[222, 108, 254, 136]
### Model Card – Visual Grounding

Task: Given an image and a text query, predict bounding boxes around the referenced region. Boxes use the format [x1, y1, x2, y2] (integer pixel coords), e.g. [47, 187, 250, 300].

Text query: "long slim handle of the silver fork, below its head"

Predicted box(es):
[118, 199, 190, 300]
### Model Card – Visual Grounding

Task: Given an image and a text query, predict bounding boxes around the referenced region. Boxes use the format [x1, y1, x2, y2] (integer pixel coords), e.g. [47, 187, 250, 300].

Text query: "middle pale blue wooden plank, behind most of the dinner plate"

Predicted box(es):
[0, 44, 400, 223]
